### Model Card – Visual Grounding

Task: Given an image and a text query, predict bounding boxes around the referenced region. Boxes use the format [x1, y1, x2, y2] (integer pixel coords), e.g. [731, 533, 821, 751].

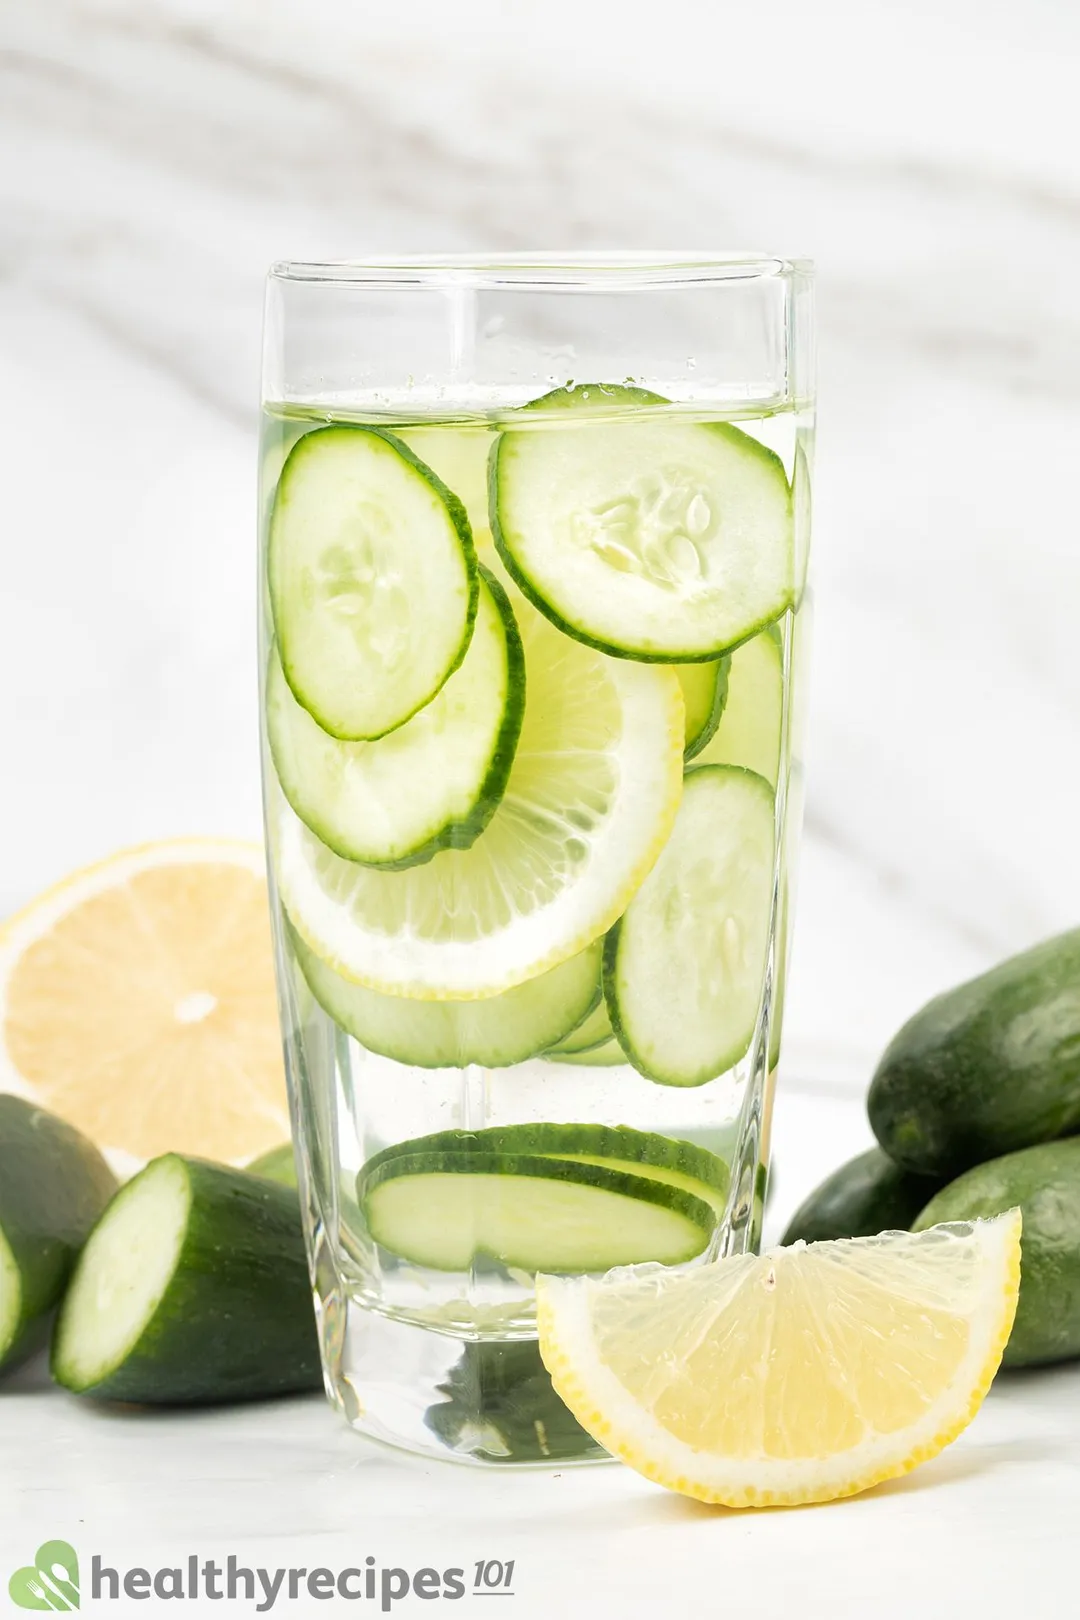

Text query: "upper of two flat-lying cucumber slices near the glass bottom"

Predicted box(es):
[364, 1121, 729, 1215]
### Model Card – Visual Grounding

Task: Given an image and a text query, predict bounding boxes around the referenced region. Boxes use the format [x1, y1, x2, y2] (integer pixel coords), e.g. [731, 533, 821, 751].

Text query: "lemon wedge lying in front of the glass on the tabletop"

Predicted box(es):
[536, 1210, 1020, 1508]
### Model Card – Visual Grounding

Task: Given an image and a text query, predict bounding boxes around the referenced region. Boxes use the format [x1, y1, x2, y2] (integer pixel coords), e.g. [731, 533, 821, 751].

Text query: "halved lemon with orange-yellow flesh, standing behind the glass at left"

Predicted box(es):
[0, 839, 288, 1165]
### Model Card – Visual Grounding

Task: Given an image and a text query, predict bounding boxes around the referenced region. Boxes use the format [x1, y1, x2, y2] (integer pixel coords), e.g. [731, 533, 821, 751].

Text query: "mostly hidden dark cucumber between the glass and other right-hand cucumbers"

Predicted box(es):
[780, 1147, 942, 1244]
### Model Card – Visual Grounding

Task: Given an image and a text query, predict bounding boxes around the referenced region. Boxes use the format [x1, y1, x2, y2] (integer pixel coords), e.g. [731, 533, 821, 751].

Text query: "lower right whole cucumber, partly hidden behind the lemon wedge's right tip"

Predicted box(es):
[913, 1139, 1080, 1367]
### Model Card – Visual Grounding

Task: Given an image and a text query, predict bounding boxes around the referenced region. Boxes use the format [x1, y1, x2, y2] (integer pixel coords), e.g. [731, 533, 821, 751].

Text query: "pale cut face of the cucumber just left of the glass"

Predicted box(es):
[53, 1153, 191, 1392]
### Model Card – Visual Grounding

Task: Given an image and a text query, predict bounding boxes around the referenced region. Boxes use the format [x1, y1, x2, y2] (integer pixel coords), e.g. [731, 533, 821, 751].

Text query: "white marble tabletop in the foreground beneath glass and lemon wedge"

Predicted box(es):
[0, 1347, 1080, 1620]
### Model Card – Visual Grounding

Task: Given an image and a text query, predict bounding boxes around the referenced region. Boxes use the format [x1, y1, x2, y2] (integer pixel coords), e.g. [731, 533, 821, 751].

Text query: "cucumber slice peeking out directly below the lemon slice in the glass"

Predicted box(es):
[293, 933, 602, 1069]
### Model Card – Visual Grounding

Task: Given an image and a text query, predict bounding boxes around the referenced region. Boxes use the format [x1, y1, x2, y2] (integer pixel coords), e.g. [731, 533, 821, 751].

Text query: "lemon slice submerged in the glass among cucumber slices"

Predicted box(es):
[272, 593, 683, 1001]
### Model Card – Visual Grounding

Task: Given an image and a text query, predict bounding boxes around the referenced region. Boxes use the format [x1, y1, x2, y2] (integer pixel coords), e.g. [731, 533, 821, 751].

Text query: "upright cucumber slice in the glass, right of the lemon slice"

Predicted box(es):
[604, 765, 776, 1085]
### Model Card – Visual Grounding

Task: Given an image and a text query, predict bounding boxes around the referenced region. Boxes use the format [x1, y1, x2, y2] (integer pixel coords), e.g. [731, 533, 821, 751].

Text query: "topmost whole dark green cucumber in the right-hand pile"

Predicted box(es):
[868, 928, 1080, 1179]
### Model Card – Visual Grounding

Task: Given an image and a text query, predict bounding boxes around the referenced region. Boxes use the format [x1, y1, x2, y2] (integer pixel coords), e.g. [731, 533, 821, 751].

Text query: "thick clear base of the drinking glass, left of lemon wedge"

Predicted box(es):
[322, 1302, 610, 1468]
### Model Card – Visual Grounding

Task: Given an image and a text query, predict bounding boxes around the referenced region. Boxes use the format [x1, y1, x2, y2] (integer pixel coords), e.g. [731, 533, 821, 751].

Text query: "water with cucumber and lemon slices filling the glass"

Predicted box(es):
[264, 382, 798, 1380]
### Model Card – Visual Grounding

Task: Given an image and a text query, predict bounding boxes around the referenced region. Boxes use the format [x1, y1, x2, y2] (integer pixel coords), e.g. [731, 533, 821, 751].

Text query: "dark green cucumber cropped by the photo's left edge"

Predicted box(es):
[0, 1092, 117, 1367]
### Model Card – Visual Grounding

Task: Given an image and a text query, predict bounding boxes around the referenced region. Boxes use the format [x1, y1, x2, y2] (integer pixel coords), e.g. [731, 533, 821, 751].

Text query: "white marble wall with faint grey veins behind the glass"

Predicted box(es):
[0, 0, 1080, 1202]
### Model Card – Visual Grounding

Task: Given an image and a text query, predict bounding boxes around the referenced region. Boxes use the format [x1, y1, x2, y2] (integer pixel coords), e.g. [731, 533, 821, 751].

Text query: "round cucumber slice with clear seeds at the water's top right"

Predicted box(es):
[489, 384, 793, 663]
